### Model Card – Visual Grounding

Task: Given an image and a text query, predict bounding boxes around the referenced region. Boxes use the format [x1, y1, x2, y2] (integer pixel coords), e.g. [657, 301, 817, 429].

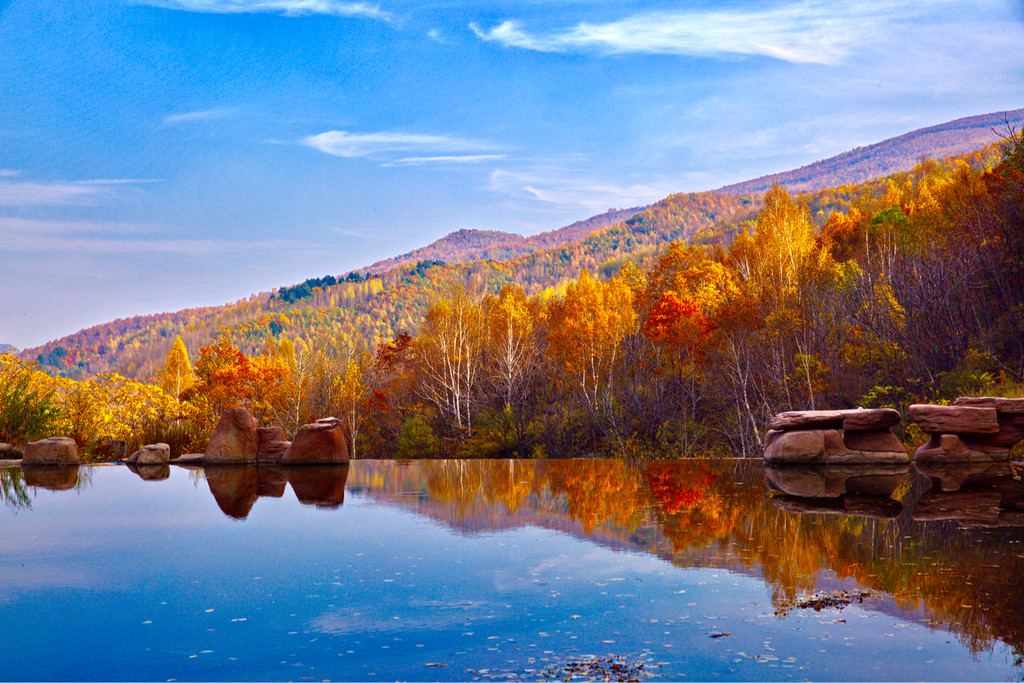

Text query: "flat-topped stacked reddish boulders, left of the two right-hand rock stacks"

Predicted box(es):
[764, 408, 910, 465]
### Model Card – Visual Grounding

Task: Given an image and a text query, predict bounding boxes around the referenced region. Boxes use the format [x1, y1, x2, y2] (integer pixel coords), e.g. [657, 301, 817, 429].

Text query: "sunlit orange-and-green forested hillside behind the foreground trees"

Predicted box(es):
[20, 193, 754, 379]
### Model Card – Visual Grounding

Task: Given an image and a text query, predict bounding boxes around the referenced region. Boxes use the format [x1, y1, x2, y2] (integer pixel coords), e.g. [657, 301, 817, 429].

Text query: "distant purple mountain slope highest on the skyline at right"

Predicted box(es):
[715, 109, 1024, 195]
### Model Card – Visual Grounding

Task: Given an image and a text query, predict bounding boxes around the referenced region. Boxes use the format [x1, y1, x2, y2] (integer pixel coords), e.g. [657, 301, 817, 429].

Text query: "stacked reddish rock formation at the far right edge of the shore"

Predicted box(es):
[909, 396, 1024, 463]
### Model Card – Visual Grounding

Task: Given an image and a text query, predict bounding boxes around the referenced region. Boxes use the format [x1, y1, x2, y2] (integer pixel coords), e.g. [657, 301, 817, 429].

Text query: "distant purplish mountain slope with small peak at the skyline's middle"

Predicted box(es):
[361, 207, 646, 274]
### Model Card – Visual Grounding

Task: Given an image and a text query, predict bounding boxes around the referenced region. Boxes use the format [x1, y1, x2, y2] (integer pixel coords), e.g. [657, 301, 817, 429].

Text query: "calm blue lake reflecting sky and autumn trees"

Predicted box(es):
[0, 460, 1024, 681]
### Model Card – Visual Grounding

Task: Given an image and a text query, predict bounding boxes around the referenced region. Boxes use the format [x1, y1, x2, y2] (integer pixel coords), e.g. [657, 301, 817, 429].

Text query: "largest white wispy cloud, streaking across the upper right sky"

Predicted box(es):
[469, 1, 921, 65]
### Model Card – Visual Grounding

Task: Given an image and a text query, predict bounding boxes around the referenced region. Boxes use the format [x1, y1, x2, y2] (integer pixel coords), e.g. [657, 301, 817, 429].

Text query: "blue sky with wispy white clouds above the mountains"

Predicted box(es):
[0, 0, 1024, 347]
